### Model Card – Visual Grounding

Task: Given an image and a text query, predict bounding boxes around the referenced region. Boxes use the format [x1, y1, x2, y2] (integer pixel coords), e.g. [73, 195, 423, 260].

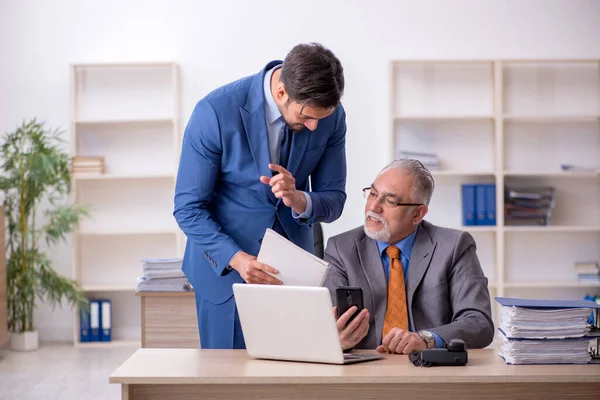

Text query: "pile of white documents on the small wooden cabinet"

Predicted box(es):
[136, 258, 192, 292]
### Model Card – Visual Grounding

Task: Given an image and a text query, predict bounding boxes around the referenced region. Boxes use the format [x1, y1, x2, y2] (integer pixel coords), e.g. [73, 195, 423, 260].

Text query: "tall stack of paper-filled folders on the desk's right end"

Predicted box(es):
[496, 297, 600, 364]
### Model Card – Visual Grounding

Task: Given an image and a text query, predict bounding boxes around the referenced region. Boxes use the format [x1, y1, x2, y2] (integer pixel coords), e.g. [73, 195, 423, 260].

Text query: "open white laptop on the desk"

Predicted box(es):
[233, 283, 383, 364]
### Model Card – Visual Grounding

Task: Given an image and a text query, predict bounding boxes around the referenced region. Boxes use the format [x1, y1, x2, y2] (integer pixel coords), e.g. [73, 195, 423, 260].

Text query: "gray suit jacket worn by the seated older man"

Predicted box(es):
[323, 221, 494, 349]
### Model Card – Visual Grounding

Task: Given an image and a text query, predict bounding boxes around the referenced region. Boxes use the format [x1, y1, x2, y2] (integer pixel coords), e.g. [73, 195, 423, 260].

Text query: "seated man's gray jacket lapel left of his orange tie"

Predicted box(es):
[356, 235, 387, 343]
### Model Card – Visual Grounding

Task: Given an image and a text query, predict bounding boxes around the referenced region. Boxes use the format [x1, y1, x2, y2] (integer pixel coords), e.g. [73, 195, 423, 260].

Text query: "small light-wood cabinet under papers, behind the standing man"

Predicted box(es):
[136, 292, 200, 349]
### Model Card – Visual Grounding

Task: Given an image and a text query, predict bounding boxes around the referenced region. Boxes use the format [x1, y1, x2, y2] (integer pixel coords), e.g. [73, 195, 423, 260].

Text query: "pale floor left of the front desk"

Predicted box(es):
[0, 344, 138, 400]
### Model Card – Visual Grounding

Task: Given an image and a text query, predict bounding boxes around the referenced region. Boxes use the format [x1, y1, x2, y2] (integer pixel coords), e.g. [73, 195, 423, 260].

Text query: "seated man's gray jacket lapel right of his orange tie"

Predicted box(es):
[406, 224, 437, 329]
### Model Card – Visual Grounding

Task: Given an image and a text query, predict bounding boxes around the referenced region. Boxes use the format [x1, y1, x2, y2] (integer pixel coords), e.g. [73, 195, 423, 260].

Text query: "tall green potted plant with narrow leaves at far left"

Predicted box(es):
[0, 119, 88, 350]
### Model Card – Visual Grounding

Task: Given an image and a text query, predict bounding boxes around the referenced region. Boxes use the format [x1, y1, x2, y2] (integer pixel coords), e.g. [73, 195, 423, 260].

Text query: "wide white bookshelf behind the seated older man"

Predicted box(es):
[388, 60, 600, 332]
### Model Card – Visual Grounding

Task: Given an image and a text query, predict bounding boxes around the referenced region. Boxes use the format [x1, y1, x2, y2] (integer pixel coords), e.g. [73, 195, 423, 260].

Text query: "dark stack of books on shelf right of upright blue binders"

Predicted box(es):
[504, 186, 556, 226]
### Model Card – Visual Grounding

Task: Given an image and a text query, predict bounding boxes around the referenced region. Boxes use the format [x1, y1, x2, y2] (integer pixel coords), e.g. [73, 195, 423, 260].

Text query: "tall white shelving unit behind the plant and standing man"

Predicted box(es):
[70, 62, 185, 347]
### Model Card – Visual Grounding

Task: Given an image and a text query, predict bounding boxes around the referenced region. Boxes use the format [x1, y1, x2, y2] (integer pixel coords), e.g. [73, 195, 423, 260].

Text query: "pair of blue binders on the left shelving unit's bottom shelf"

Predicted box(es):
[79, 299, 112, 343]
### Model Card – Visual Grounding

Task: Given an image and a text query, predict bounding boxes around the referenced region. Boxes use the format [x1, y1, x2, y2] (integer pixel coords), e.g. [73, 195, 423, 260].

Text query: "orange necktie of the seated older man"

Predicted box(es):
[381, 246, 408, 339]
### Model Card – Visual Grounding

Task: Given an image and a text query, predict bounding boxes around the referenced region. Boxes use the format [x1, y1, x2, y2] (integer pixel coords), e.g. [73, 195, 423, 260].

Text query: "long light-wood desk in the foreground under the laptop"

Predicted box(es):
[110, 349, 600, 400]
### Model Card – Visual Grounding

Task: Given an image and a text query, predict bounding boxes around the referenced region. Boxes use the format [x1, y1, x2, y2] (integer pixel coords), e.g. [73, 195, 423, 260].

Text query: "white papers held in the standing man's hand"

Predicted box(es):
[257, 229, 329, 286]
